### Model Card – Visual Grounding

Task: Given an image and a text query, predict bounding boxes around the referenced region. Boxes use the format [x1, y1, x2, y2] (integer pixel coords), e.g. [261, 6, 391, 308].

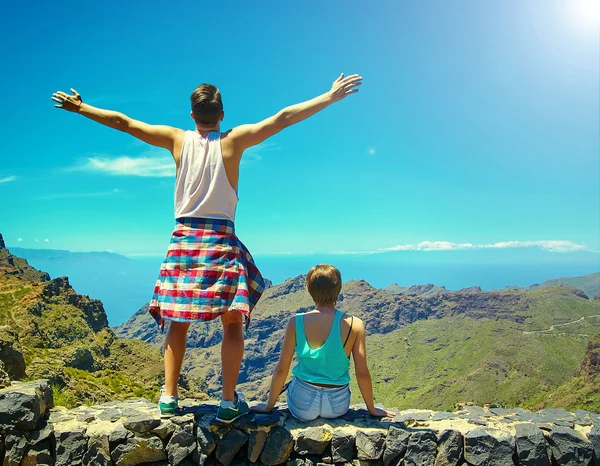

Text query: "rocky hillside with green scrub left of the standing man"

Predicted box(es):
[0, 235, 206, 406]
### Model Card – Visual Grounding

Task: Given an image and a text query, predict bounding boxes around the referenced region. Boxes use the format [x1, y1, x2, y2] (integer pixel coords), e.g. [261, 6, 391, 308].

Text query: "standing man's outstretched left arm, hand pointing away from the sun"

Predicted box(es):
[52, 89, 185, 160]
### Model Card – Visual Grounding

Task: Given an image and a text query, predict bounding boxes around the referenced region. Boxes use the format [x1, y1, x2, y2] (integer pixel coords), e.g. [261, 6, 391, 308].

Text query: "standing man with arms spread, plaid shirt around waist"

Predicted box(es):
[52, 74, 362, 423]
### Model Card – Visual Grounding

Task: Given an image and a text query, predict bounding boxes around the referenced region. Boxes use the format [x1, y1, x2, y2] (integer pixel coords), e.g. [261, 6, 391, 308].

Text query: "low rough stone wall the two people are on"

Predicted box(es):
[0, 381, 600, 466]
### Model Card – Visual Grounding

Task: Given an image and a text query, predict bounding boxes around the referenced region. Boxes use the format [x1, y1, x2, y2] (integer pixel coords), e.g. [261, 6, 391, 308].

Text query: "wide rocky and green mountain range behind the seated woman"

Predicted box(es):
[115, 276, 600, 409]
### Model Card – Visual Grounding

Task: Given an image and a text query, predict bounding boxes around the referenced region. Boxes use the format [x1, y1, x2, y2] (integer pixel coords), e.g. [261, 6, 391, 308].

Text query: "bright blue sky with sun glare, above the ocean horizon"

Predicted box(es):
[0, 0, 600, 262]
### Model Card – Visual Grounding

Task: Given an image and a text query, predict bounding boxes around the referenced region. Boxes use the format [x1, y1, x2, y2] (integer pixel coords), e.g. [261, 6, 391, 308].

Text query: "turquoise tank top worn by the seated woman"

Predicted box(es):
[292, 309, 350, 385]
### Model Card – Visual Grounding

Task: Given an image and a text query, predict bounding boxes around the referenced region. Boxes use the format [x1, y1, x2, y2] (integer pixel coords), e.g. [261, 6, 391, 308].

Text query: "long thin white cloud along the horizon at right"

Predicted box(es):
[331, 240, 597, 254]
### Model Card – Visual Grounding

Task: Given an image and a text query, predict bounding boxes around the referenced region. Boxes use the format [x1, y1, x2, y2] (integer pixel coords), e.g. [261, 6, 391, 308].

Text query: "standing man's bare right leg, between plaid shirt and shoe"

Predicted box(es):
[221, 311, 244, 403]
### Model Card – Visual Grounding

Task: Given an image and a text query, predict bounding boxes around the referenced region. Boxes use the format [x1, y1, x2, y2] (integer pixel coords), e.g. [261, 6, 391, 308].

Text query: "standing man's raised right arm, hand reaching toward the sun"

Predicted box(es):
[231, 73, 362, 154]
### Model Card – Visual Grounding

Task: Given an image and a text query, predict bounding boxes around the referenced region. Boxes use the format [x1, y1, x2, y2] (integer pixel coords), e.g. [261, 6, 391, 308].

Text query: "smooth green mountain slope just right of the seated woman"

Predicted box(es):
[358, 317, 600, 410]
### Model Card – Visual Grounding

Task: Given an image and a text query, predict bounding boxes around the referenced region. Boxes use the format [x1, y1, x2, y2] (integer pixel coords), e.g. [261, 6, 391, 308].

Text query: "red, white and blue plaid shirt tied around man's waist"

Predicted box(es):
[148, 218, 264, 325]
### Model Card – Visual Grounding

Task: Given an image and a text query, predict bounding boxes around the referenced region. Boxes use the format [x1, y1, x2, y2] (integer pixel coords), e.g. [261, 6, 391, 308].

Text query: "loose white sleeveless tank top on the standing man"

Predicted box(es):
[175, 131, 238, 222]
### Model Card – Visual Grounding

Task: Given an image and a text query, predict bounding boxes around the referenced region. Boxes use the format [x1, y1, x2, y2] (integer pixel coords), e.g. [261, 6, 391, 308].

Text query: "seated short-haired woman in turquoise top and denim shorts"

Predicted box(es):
[253, 264, 394, 421]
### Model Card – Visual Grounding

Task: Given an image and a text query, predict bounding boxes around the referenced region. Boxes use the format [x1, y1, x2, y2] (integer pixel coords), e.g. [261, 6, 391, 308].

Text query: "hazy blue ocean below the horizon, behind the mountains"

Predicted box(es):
[10, 248, 600, 326]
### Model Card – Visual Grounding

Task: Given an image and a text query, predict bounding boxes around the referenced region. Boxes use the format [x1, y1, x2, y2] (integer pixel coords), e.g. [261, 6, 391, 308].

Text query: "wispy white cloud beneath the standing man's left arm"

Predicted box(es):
[70, 153, 175, 177]
